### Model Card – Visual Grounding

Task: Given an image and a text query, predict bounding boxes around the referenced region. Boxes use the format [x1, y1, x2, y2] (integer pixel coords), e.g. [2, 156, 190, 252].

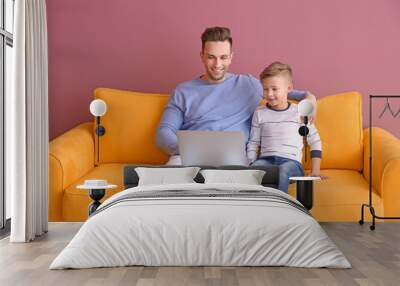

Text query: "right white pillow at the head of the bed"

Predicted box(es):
[200, 170, 265, 185]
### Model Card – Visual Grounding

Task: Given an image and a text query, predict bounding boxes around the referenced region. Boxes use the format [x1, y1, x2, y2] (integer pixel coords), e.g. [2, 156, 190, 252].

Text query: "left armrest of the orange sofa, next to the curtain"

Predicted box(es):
[49, 122, 95, 221]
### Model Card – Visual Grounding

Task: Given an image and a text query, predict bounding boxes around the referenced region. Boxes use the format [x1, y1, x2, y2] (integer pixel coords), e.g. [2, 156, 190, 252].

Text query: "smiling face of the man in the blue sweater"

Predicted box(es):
[200, 41, 233, 82]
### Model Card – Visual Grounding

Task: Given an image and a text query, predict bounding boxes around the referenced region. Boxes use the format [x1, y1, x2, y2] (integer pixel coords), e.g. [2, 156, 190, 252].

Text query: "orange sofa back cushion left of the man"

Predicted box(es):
[94, 88, 168, 164]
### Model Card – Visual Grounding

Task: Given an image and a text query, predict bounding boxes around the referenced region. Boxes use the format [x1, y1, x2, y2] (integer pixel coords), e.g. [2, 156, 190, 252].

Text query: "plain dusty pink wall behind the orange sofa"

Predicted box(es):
[47, 0, 400, 138]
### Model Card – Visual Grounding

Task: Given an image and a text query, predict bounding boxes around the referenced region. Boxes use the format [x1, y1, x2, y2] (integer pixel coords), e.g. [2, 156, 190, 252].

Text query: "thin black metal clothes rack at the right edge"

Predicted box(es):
[358, 95, 400, 230]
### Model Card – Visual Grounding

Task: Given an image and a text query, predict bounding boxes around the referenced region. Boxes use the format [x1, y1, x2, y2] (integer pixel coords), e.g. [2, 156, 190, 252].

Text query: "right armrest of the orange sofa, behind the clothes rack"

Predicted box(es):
[363, 127, 400, 216]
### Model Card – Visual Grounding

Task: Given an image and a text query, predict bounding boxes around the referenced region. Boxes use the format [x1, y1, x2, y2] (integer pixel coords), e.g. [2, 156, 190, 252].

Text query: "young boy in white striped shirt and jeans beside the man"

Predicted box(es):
[247, 62, 322, 193]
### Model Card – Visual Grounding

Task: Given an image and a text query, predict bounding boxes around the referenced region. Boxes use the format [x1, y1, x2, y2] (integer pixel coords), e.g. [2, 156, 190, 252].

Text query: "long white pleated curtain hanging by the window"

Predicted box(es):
[5, 0, 49, 242]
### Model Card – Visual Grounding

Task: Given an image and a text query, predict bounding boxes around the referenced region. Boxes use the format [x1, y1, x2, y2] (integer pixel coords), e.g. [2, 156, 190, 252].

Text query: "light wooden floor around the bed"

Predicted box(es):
[0, 222, 400, 286]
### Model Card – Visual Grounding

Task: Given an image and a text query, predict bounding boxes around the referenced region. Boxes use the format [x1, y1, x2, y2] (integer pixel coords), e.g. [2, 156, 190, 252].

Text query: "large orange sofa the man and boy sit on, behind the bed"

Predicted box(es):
[49, 88, 400, 221]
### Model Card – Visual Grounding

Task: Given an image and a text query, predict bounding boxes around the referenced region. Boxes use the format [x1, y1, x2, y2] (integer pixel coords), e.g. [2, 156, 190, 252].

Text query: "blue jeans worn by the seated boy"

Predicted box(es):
[252, 156, 304, 193]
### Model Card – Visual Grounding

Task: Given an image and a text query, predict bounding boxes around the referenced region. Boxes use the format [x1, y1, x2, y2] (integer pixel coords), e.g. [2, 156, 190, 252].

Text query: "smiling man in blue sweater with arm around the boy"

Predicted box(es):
[157, 27, 315, 165]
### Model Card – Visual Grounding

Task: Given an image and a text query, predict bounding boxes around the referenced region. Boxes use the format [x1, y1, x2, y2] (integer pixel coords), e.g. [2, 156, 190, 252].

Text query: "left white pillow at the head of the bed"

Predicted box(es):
[135, 167, 200, 186]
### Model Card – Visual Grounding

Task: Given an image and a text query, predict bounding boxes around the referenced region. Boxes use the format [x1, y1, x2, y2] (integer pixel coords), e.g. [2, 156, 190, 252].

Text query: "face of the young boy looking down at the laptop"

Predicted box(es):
[262, 75, 293, 108]
